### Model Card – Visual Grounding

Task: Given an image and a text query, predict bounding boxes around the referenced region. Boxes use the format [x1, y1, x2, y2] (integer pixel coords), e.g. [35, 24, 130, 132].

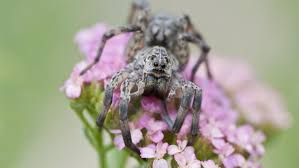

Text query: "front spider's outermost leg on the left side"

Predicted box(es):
[96, 68, 130, 128]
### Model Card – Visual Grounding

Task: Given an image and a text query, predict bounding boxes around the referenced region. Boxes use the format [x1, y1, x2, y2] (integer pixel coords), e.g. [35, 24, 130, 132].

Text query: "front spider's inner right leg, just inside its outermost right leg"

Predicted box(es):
[172, 85, 193, 133]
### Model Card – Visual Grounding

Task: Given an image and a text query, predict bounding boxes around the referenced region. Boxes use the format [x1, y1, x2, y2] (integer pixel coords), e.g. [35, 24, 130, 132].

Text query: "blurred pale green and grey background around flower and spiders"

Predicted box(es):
[0, 0, 299, 168]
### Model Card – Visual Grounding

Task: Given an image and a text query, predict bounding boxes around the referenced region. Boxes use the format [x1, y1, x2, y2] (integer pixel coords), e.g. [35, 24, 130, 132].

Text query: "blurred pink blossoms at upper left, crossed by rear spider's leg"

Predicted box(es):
[75, 24, 131, 82]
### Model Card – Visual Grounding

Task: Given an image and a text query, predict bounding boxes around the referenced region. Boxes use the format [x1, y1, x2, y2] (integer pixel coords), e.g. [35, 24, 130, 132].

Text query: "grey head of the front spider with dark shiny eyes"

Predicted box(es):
[144, 46, 175, 77]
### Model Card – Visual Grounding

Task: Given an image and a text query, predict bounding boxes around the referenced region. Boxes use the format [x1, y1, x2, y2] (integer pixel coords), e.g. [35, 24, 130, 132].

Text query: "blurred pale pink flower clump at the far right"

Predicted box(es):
[234, 83, 291, 129]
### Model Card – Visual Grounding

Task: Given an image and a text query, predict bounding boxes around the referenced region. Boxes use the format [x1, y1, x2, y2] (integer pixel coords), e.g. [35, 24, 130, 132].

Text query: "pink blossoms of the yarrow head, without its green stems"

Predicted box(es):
[62, 24, 288, 168]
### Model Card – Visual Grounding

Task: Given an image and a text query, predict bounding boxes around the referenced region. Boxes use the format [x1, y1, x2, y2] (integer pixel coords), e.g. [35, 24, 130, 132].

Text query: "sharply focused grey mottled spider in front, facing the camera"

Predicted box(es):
[96, 46, 202, 154]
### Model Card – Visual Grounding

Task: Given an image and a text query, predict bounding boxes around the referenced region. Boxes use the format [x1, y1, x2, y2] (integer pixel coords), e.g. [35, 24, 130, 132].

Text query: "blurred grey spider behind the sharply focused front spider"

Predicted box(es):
[81, 0, 212, 81]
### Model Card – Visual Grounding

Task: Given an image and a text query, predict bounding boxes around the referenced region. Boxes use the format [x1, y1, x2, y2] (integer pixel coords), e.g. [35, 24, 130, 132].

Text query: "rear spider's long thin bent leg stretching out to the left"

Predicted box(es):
[80, 25, 141, 75]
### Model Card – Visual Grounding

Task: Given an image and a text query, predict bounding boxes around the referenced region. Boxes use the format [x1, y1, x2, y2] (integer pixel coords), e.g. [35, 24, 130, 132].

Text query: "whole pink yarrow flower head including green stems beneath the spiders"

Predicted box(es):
[61, 24, 290, 168]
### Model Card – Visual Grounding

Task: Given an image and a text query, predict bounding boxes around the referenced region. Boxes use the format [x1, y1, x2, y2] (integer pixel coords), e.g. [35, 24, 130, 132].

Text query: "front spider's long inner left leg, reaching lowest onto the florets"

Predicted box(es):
[119, 79, 143, 155]
